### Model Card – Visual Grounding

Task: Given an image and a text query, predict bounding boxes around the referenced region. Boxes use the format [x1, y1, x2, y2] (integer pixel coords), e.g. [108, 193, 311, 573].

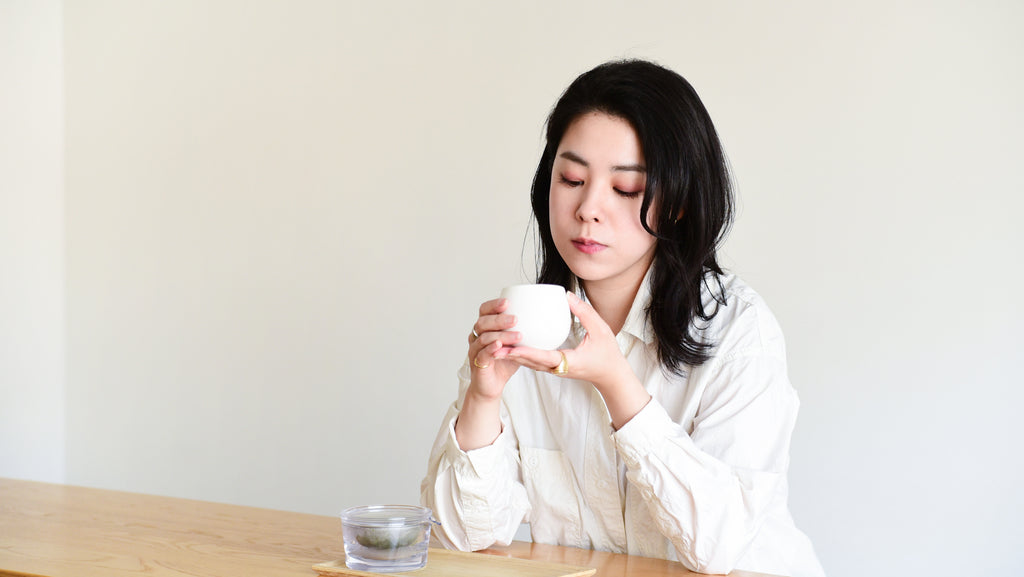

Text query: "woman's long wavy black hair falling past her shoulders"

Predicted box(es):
[530, 60, 733, 374]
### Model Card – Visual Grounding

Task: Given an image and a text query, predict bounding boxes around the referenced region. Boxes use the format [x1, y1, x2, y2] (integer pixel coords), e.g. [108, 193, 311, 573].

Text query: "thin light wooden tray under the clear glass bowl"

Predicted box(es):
[313, 547, 597, 577]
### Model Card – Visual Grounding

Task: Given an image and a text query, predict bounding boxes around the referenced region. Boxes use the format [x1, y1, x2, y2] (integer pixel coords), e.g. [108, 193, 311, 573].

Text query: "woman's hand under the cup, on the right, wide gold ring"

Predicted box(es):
[508, 293, 650, 428]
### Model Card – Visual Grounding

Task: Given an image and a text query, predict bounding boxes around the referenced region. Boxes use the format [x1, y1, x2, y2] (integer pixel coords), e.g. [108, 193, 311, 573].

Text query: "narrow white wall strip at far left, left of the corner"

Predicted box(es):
[0, 0, 65, 482]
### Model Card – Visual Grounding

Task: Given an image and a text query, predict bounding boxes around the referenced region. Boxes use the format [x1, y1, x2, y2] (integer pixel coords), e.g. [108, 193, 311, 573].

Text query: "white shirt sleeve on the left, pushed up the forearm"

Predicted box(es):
[420, 365, 529, 550]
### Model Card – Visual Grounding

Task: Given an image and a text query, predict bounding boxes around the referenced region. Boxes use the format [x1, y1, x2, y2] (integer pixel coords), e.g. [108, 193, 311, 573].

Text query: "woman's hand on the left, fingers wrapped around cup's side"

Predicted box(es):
[468, 298, 522, 400]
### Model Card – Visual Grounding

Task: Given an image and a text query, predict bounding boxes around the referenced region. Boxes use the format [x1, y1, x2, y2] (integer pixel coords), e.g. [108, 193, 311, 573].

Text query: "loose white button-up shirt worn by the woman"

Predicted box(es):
[421, 275, 824, 577]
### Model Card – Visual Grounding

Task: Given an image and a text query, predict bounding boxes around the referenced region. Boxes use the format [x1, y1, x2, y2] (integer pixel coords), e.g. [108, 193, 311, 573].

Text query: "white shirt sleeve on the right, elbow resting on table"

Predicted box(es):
[613, 352, 799, 573]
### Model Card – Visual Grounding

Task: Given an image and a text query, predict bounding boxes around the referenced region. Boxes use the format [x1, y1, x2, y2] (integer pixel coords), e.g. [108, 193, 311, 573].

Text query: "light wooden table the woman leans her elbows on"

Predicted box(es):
[0, 479, 759, 577]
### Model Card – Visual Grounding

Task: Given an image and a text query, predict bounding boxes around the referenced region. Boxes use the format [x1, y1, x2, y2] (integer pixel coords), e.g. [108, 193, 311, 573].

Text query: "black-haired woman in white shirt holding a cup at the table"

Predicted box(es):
[422, 60, 823, 576]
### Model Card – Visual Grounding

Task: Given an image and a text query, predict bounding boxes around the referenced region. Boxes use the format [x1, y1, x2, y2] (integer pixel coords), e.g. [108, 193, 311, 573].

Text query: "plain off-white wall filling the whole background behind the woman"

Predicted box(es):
[0, 0, 1024, 576]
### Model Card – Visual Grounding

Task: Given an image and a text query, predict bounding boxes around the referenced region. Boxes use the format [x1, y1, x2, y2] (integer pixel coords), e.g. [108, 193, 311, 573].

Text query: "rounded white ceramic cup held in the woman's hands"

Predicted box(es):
[501, 285, 572, 351]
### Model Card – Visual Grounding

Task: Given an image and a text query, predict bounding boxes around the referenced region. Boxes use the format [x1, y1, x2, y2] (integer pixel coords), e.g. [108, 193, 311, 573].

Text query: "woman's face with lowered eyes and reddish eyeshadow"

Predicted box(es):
[548, 112, 656, 290]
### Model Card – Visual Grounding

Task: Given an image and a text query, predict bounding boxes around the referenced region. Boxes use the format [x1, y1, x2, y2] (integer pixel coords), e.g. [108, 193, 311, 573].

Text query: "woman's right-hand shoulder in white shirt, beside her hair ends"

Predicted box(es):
[700, 274, 785, 362]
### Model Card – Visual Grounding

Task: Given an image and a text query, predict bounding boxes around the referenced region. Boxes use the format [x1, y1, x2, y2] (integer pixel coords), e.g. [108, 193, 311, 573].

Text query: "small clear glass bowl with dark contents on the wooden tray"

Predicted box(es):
[341, 505, 431, 573]
